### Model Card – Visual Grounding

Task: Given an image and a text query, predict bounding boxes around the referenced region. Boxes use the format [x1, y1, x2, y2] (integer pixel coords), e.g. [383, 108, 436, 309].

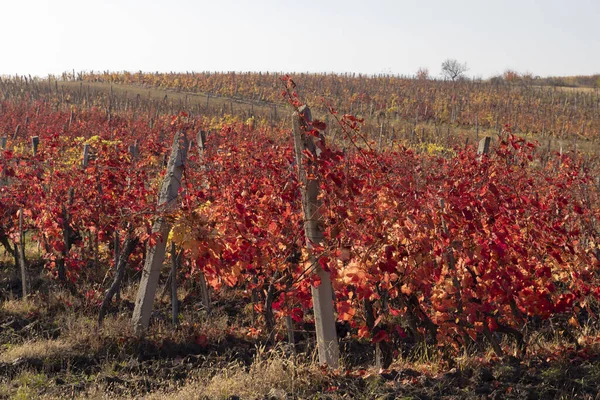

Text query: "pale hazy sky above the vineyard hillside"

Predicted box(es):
[0, 0, 600, 78]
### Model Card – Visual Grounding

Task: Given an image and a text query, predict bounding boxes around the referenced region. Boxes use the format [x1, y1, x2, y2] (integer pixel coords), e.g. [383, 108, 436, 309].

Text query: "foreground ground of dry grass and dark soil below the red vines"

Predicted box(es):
[0, 265, 600, 400]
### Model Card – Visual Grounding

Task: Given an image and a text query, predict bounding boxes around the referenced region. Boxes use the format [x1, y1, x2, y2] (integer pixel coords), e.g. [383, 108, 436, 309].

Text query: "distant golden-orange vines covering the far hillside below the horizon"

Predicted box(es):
[72, 72, 600, 140]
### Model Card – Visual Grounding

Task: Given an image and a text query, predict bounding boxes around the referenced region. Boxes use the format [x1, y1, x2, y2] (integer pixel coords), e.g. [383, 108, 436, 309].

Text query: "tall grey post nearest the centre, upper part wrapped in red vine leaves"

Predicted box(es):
[292, 106, 340, 368]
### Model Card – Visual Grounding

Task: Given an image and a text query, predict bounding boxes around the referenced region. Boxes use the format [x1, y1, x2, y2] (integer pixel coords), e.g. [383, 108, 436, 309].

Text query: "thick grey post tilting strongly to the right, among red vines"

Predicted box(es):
[132, 132, 188, 335]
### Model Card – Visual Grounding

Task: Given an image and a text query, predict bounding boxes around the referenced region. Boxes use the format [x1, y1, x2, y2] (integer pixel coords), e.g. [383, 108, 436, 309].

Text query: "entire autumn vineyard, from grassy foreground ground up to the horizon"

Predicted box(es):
[0, 73, 600, 399]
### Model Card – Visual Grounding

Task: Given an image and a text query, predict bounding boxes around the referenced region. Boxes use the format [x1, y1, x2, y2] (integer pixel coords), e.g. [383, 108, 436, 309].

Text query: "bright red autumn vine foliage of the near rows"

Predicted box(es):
[0, 81, 600, 368]
